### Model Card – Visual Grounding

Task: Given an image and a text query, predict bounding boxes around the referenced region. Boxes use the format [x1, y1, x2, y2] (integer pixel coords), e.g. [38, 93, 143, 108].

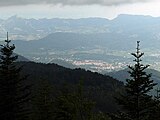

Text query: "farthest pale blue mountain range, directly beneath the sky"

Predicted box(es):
[0, 14, 160, 41]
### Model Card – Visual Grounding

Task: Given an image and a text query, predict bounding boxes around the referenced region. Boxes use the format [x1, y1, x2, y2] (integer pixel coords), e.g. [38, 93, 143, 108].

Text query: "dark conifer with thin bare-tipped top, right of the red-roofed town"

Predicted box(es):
[117, 41, 156, 120]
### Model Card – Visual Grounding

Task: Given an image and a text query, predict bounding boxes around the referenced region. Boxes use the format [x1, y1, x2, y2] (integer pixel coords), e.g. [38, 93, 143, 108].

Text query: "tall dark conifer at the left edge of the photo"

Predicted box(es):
[0, 33, 30, 120]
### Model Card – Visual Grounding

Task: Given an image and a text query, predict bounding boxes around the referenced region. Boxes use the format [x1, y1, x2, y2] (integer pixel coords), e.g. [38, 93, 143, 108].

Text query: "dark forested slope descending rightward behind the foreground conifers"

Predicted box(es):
[17, 62, 123, 112]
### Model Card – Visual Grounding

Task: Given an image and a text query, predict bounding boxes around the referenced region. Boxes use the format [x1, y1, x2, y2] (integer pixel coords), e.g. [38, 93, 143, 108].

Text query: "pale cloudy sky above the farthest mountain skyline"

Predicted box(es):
[0, 0, 160, 19]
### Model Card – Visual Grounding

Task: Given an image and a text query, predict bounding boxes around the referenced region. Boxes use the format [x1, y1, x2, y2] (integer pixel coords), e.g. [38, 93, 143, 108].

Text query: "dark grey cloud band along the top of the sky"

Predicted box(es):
[0, 0, 150, 6]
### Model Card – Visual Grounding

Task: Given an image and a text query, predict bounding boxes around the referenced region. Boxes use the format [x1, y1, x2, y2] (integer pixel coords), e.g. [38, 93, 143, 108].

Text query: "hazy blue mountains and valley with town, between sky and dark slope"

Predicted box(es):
[0, 15, 160, 73]
